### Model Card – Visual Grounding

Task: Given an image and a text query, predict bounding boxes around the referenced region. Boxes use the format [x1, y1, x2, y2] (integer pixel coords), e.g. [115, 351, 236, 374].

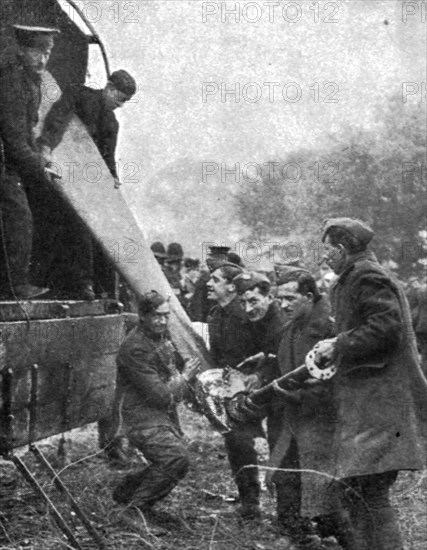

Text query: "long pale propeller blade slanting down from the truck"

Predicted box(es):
[53, 116, 213, 376]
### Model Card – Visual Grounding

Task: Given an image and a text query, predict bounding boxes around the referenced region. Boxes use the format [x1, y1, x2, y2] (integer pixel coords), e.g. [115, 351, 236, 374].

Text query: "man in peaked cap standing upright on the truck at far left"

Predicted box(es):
[0, 25, 59, 299]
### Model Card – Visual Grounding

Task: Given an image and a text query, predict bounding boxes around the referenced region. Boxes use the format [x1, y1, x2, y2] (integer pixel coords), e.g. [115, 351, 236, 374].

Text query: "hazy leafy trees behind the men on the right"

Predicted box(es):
[236, 98, 427, 276]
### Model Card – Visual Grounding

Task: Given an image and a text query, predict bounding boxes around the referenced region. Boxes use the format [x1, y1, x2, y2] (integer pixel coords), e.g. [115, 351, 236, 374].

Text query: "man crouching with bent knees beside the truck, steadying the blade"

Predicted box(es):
[113, 291, 200, 512]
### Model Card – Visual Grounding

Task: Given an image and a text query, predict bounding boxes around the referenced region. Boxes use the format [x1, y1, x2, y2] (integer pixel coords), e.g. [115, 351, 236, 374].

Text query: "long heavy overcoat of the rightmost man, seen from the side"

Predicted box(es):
[331, 252, 427, 478]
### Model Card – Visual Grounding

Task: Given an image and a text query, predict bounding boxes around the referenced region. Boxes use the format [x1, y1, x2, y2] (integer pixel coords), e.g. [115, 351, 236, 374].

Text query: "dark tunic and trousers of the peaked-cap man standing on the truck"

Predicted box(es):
[0, 58, 46, 285]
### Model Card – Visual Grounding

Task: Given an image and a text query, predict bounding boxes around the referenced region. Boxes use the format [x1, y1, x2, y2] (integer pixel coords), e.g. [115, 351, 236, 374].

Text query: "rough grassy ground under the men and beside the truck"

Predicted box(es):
[0, 409, 427, 550]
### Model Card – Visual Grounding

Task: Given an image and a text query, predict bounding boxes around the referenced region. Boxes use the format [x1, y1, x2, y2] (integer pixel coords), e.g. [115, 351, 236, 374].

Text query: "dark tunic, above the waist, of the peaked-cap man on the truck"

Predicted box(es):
[0, 59, 46, 182]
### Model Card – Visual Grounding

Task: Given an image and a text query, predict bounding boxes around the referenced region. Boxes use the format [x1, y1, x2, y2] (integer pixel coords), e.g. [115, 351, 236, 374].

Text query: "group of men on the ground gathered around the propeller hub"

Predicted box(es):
[110, 218, 427, 550]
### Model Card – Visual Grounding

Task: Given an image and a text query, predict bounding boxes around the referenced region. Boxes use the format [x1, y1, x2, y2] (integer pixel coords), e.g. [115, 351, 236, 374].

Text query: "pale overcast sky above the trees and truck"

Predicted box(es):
[65, 0, 426, 254]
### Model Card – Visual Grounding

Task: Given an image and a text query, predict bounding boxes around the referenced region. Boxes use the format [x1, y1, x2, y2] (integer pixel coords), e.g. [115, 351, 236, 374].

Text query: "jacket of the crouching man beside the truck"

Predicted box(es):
[115, 327, 183, 429]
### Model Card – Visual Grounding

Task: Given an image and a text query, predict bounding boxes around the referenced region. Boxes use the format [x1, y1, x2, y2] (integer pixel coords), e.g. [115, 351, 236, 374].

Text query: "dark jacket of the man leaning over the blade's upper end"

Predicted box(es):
[40, 85, 119, 178]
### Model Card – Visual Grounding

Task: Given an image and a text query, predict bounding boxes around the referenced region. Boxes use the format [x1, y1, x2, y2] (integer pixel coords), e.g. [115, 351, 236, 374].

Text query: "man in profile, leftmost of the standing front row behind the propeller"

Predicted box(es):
[207, 261, 263, 519]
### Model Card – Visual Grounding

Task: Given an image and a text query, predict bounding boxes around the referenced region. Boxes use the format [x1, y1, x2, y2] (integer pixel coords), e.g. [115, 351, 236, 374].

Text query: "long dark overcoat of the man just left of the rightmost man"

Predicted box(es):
[268, 296, 336, 516]
